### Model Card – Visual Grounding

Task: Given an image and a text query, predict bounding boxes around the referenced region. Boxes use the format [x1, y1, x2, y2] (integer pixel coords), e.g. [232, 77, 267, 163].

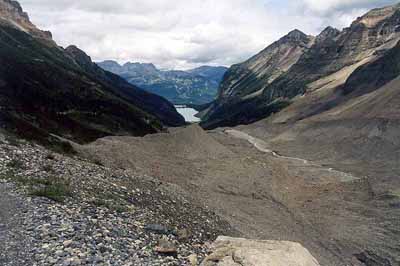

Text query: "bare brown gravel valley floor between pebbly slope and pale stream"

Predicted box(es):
[78, 126, 400, 266]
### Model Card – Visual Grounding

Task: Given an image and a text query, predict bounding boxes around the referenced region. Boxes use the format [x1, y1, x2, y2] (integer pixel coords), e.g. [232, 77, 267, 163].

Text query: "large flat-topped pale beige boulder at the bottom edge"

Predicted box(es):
[201, 236, 319, 266]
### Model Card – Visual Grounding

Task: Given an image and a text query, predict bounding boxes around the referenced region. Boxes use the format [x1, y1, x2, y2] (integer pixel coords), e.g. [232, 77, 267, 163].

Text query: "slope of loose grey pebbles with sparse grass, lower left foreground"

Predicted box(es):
[0, 136, 235, 266]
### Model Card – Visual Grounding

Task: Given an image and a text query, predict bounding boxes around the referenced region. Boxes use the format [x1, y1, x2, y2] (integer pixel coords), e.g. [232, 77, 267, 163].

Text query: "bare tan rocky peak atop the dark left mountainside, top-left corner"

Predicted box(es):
[0, 0, 52, 41]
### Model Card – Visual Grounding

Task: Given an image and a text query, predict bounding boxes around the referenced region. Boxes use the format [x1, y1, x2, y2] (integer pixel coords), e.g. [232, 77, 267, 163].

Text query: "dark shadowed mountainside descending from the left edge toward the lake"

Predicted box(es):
[0, 0, 185, 142]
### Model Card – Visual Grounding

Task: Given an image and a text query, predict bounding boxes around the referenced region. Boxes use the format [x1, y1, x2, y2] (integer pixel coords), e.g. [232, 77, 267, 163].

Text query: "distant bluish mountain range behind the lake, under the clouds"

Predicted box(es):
[97, 61, 228, 104]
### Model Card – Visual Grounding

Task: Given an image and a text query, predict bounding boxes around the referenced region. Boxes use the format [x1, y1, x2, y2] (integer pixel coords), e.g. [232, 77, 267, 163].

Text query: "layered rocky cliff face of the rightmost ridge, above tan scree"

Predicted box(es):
[264, 5, 400, 101]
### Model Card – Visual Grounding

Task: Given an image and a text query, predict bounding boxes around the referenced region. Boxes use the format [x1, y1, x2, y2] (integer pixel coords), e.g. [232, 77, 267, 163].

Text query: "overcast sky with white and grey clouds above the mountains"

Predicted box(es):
[19, 0, 398, 69]
